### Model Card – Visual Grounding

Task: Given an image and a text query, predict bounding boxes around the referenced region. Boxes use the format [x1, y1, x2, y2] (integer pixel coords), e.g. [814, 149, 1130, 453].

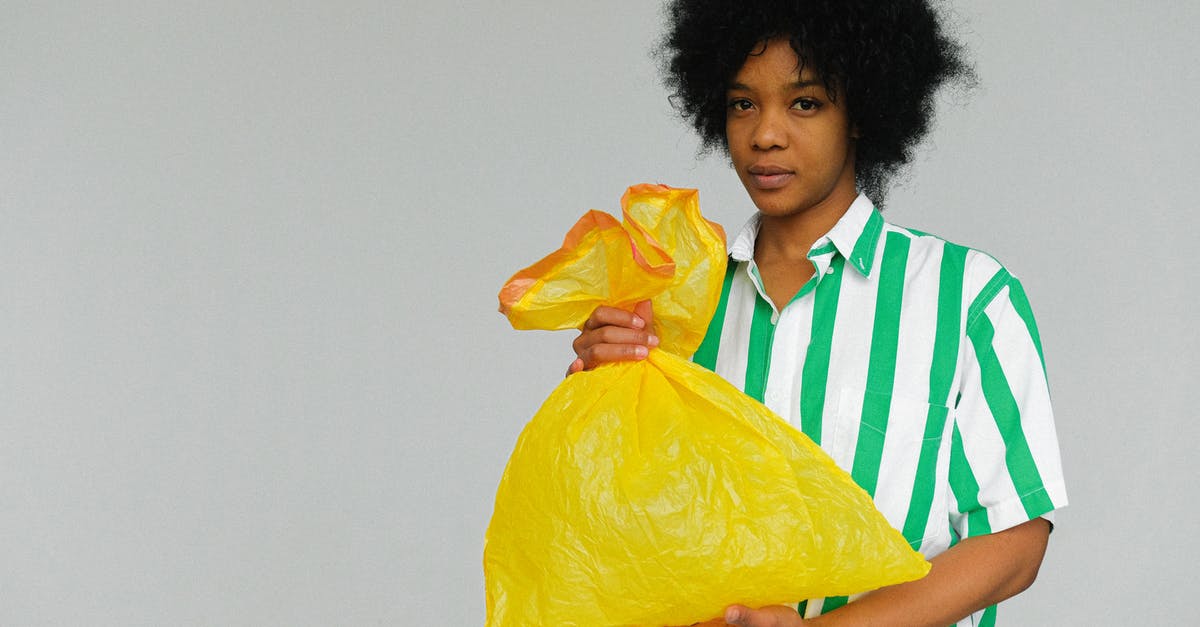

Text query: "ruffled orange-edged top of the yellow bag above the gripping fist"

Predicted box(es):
[500, 184, 726, 357]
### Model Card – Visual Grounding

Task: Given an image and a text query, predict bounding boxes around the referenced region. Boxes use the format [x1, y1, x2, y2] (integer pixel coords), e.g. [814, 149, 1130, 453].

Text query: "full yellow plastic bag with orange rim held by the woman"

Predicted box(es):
[484, 185, 929, 627]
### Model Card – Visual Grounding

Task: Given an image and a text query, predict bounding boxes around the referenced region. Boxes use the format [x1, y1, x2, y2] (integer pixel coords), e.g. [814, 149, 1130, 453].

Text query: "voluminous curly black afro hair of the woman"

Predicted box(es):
[658, 0, 974, 205]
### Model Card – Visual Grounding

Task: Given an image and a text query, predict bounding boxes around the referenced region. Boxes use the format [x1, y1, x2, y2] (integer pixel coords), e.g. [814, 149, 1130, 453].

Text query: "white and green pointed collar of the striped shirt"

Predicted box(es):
[730, 193, 883, 276]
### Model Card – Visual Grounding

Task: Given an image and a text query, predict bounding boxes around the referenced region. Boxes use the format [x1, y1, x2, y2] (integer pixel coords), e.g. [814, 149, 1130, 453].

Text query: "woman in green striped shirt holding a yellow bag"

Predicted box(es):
[570, 0, 1067, 626]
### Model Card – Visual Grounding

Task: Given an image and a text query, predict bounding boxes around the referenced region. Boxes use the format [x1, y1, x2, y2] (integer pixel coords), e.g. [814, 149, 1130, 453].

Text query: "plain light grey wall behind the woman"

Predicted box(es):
[0, 0, 1200, 626]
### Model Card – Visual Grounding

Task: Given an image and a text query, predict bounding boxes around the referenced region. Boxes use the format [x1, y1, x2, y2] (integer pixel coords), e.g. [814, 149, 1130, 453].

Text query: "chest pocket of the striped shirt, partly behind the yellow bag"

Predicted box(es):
[829, 388, 949, 535]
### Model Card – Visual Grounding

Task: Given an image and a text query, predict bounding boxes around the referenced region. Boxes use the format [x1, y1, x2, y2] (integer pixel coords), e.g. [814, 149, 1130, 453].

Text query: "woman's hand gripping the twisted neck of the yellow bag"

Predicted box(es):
[566, 300, 659, 376]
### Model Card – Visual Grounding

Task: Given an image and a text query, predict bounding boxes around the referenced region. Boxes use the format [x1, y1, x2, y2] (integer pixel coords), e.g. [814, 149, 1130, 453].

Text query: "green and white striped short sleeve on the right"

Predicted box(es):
[949, 268, 1067, 538]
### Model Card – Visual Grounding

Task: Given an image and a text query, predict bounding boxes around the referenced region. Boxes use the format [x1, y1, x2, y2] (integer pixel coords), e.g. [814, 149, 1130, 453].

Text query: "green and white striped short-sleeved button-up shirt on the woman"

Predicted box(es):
[692, 195, 1067, 625]
